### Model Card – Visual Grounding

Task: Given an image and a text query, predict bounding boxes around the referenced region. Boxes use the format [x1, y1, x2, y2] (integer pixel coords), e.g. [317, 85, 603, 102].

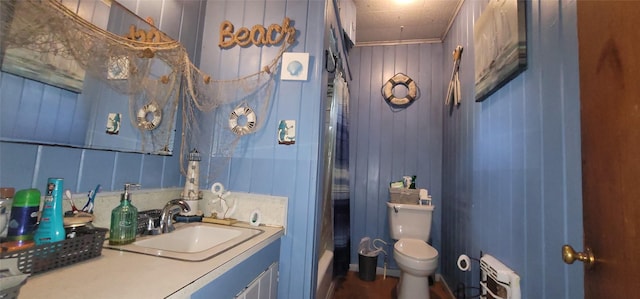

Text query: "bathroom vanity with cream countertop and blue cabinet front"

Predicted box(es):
[20, 222, 284, 299]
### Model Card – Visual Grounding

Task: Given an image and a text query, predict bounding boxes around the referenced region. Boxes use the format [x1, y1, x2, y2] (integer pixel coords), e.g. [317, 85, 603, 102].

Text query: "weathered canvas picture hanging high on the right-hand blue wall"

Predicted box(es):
[473, 0, 527, 102]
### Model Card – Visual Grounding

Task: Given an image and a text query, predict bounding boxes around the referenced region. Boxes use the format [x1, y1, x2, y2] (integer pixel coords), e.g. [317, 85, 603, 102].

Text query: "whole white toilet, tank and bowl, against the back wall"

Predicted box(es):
[387, 202, 438, 299]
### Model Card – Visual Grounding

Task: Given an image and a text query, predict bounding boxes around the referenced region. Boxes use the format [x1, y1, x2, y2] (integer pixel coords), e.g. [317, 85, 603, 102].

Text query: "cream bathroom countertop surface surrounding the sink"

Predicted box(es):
[19, 223, 283, 299]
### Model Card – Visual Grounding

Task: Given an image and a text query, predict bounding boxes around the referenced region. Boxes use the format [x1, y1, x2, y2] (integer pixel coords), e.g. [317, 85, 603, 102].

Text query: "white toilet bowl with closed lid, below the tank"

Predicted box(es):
[393, 239, 438, 299]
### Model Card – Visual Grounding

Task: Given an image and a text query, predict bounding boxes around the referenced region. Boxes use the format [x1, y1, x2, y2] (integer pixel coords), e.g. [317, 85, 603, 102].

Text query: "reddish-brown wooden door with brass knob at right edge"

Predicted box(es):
[574, 1, 640, 299]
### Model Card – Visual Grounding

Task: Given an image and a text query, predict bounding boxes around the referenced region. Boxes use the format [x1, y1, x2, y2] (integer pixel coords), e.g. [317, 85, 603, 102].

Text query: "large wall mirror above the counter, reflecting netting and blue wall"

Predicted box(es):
[0, 0, 180, 155]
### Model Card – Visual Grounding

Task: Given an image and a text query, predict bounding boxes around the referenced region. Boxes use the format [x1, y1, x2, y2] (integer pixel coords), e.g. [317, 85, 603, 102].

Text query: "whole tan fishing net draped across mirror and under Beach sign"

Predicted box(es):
[0, 0, 293, 175]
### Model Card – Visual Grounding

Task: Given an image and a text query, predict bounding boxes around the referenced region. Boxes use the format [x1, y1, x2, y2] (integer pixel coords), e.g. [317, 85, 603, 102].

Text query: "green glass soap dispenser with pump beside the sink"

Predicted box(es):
[109, 184, 140, 245]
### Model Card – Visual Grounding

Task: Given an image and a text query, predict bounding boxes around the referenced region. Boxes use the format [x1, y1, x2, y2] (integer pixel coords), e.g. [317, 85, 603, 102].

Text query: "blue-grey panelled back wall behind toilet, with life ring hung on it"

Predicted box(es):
[349, 43, 444, 269]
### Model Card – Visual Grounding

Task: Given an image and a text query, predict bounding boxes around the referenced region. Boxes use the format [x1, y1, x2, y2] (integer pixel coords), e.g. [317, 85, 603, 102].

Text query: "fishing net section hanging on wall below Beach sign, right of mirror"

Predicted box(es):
[180, 55, 280, 180]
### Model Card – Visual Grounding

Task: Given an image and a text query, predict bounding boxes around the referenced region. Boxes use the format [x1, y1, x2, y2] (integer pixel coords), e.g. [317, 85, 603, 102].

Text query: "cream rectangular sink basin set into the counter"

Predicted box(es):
[104, 222, 264, 261]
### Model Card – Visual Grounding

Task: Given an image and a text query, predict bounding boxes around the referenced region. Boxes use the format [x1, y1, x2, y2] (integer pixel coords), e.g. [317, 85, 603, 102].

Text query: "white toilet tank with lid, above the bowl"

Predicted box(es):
[387, 202, 434, 241]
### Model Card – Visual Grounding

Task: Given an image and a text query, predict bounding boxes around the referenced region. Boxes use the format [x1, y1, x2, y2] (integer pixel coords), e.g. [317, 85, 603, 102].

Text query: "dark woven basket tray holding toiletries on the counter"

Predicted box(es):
[0, 227, 109, 274]
